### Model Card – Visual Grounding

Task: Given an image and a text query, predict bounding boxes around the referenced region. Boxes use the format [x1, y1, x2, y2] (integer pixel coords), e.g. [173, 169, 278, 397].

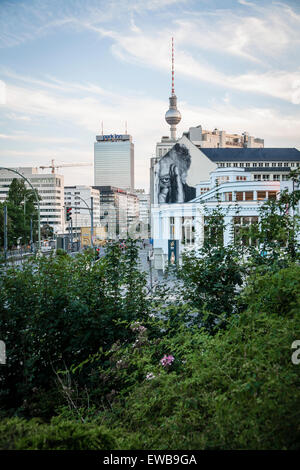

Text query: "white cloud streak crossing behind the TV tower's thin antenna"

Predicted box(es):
[89, 22, 300, 104]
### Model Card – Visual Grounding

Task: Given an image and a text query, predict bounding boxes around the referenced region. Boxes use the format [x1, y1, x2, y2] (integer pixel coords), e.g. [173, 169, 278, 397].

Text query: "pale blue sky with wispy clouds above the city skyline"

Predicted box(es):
[0, 0, 300, 190]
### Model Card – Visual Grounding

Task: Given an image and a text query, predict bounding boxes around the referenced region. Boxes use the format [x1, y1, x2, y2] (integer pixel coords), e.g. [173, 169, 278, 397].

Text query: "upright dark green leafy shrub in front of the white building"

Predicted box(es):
[177, 207, 243, 332]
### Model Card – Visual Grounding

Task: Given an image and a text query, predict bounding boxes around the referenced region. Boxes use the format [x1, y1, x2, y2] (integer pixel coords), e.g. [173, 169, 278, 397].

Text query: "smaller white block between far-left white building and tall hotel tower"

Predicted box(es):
[64, 185, 100, 233]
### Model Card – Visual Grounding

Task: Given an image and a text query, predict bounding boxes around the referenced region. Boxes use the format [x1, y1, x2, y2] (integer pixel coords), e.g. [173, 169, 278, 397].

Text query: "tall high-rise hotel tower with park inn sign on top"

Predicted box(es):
[94, 134, 134, 190]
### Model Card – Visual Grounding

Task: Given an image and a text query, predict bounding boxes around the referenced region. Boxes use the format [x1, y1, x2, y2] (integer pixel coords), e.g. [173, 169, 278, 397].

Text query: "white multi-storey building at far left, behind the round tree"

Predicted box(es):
[0, 167, 64, 233]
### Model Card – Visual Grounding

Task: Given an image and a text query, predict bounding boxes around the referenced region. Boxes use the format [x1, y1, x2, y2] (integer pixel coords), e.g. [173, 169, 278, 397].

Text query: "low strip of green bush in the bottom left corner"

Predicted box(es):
[0, 418, 116, 450]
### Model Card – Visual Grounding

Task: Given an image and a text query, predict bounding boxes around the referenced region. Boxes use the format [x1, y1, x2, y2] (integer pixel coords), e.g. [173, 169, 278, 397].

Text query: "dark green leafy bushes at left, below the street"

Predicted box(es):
[0, 242, 147, 416]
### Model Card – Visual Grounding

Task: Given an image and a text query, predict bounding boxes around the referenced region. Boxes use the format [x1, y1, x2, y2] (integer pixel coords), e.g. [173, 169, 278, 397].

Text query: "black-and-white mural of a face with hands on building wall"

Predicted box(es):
[156, 144, 196, 204]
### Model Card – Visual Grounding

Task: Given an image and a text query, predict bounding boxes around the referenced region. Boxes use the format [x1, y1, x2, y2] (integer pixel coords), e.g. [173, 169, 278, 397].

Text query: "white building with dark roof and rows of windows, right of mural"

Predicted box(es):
[151, 149, 300, 269]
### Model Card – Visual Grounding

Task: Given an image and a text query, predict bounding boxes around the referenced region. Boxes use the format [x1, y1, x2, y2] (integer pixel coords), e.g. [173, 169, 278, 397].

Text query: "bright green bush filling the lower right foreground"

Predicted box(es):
[98, 266, 300, 450]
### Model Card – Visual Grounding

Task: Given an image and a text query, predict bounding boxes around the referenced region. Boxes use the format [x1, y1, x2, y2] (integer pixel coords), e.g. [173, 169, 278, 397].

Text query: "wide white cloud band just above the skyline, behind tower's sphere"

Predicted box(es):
[0, 72, 300, 189]
